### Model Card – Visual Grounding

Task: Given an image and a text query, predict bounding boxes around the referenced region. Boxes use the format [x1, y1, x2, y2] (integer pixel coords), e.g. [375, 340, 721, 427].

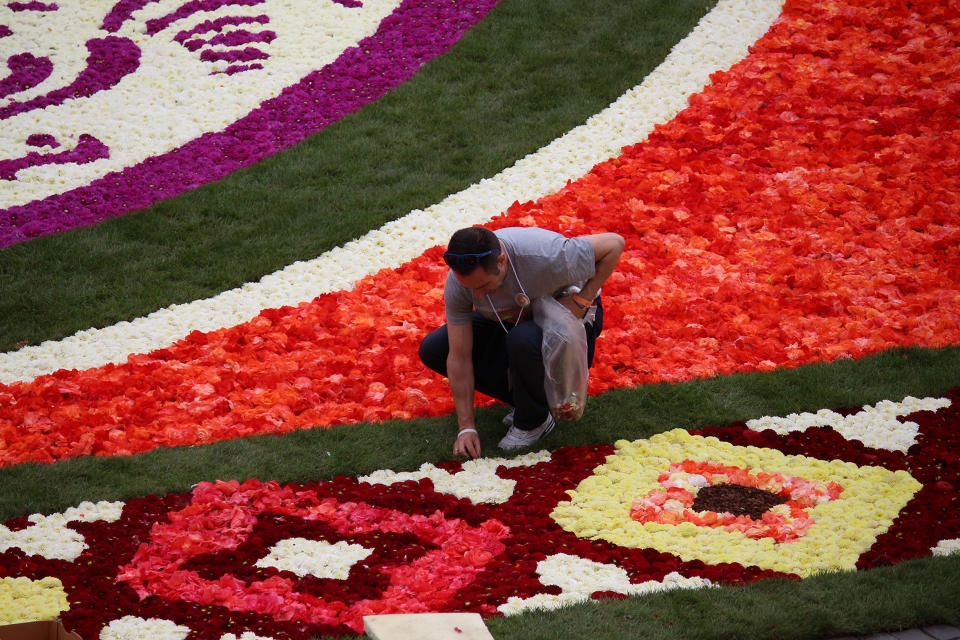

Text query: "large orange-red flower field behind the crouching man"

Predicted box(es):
[0, 0, 960, 465]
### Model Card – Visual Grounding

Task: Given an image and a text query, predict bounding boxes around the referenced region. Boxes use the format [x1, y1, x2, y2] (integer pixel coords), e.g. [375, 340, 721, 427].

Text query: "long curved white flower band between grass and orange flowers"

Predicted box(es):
[0, 0, 782, 384]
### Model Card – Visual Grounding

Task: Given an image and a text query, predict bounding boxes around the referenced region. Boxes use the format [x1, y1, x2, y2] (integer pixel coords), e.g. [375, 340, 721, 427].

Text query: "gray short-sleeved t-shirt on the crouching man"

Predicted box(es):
[443, 227, 597, 324]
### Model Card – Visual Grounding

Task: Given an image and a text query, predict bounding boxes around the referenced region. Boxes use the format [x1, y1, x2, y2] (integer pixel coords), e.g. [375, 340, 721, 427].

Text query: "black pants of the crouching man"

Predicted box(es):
[420, 297, 603, 430]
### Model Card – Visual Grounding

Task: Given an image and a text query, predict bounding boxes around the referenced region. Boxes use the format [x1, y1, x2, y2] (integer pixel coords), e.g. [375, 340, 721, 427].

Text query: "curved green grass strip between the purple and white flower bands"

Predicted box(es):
[0, 0, 715, 351]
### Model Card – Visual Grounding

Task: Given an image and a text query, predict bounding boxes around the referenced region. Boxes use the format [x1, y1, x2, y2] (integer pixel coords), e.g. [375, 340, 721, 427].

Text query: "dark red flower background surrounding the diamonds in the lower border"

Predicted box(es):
[0, 387, 960, 640]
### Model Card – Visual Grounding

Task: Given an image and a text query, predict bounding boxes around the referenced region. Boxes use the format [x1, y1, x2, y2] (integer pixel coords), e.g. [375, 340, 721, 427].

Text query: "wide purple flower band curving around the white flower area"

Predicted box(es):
[0, 0, 499, 248]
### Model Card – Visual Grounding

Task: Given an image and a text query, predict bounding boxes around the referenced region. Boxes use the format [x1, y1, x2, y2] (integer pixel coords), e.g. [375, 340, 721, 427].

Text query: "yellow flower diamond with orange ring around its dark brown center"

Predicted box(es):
[553, 430, 921, 576]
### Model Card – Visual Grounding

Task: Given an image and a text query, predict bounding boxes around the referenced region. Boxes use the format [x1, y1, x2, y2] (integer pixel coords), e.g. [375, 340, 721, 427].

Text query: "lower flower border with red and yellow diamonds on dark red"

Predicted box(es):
[0, 388, 960, 640]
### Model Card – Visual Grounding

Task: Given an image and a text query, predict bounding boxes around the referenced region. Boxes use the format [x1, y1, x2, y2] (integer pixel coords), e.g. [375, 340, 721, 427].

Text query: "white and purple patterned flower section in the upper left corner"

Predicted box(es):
[0, 0, 496, 247]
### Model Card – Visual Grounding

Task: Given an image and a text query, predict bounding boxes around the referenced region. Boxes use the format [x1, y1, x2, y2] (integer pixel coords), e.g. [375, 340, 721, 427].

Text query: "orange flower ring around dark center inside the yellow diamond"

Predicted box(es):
[630, 460, 843, 542]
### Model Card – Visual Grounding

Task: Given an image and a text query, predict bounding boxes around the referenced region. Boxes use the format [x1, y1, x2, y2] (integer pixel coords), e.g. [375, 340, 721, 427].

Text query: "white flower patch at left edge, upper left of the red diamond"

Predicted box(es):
[0, 502, 123, 561]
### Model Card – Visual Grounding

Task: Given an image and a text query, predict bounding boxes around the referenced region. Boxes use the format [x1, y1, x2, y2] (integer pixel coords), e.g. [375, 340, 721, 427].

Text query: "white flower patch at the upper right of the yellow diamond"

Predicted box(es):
[747, 396, 950, 451]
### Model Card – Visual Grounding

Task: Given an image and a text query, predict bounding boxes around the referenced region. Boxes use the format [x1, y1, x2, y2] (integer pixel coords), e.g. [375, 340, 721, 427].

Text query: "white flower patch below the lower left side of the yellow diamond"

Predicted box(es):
[498, 553, 711, 615]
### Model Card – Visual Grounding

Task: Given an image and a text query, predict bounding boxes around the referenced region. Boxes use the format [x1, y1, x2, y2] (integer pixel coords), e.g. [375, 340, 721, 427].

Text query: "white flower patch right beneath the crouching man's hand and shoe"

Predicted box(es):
[358, 451, 550, 504]
